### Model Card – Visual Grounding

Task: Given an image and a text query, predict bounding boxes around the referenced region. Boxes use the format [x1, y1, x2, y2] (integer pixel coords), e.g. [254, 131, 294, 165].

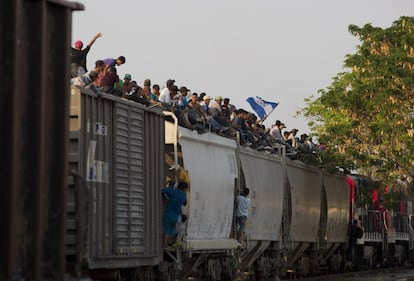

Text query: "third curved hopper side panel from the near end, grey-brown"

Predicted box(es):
[286, 161, 322, 242]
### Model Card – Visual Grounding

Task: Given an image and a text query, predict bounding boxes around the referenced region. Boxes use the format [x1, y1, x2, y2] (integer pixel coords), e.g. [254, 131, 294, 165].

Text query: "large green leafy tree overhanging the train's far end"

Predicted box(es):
[301, 17, 414, 189]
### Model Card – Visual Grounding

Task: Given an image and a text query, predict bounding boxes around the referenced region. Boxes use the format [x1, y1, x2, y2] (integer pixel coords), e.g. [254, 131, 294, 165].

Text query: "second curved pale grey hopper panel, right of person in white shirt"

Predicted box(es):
[240, 149, 284, 241]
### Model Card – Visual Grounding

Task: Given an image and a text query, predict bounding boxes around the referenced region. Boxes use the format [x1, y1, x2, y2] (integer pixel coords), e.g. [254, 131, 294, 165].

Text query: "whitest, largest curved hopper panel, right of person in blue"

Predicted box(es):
[179, 128, 237, 240]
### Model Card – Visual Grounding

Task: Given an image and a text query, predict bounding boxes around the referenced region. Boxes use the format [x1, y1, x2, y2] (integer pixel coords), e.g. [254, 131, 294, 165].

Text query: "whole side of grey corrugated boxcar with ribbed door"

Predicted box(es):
[68, 89, 164, 269]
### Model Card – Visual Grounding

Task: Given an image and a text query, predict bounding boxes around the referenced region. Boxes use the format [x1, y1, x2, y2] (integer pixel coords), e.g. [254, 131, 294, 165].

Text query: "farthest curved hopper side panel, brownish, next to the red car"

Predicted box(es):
[324, 174, 349, 242]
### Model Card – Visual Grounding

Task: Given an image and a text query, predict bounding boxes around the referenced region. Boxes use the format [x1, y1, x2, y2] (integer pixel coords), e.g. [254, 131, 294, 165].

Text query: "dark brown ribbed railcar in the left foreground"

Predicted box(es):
[0, 0, 82, 280]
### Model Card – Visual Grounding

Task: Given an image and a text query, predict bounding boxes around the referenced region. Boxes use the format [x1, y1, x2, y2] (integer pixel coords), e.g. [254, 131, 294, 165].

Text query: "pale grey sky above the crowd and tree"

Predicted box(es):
[72, 0, 414, 134]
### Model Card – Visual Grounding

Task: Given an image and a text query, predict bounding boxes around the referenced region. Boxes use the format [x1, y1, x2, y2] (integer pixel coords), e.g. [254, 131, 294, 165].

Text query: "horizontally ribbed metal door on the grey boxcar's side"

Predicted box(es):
[115, 104, 144, 253]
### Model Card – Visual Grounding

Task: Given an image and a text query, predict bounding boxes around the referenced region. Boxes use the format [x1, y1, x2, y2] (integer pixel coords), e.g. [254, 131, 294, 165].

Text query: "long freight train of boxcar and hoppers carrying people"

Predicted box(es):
[65, 88, 414, 281]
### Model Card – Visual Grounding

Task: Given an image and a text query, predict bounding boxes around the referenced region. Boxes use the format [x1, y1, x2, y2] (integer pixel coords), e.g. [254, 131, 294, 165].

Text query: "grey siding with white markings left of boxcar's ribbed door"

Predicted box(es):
[79, 88, 114, 262]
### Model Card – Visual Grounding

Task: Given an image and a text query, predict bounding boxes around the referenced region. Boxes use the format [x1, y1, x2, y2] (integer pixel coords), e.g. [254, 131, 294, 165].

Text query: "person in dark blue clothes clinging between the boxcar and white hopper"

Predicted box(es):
[162, 182, 188, 247]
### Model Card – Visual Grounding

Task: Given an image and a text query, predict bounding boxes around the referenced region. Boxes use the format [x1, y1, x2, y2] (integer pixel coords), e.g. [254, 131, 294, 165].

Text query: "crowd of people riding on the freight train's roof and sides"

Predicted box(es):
[71, 33, 323, 245]
